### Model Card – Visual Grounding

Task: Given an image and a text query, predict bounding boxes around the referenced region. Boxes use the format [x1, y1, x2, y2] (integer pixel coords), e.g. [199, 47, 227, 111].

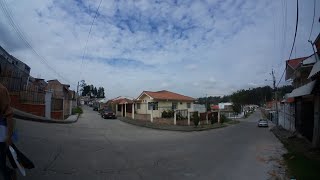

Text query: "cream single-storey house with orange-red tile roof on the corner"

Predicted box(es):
[135, 90, 195, 118]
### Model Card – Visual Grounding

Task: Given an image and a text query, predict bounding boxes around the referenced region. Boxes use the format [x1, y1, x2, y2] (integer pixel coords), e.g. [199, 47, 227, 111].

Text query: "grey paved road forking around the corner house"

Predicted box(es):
[17, 107, 282, 180]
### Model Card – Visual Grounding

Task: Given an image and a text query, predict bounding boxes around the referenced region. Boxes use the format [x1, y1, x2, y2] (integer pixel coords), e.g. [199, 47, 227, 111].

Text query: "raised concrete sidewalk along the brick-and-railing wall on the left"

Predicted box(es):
[13, 108, 79, 124]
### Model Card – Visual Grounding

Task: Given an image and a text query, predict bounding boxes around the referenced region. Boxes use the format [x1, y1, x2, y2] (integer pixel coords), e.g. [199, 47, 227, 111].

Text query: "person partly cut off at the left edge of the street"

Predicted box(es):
[0, 64, 14, 180]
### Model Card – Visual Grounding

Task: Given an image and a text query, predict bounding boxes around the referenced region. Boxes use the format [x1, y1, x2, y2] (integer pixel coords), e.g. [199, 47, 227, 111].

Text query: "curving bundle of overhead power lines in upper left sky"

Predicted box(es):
[0, 0, 71, 84]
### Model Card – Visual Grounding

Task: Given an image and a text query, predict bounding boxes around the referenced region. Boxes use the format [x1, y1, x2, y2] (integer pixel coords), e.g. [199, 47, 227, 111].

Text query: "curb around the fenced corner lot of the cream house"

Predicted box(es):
[118, 118, 232, 132]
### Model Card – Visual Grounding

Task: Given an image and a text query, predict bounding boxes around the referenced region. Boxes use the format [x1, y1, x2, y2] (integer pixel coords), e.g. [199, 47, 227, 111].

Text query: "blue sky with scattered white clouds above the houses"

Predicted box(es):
[0, 0, 320, 98]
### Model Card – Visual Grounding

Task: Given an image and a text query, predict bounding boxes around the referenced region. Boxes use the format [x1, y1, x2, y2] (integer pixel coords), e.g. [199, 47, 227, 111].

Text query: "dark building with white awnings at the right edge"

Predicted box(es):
[278, 33, 320, 147]
